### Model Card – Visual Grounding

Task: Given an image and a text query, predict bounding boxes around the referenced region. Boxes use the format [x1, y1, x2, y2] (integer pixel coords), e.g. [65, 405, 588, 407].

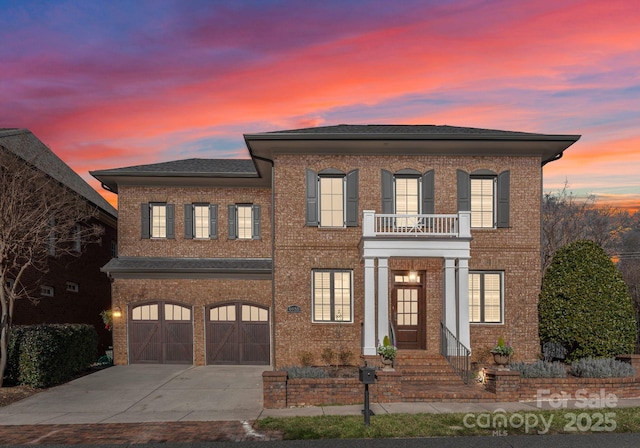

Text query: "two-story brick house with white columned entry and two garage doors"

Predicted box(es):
[92, 125, 579, 368]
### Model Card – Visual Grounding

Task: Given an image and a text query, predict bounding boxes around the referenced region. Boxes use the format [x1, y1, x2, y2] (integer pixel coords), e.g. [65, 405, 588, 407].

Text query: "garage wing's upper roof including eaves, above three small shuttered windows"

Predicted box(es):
[90, 159, 269, 193]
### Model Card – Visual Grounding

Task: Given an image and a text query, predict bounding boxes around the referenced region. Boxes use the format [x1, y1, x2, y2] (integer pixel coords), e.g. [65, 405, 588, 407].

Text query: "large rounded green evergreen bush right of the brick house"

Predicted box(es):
[538, 240, 636, 361]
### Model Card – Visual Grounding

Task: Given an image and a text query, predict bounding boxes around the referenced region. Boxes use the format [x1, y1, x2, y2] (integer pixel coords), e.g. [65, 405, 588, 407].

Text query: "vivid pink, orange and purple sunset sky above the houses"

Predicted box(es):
[0, 0, 640, 208]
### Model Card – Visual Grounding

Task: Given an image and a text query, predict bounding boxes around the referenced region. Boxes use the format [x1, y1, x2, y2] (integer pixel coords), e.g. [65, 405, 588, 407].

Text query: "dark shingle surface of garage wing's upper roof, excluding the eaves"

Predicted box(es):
[91, 159, 258, 177]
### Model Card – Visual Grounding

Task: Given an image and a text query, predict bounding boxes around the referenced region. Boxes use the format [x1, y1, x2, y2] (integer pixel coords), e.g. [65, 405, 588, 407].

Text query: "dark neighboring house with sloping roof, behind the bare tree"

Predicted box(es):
[0, 129, 118, 353]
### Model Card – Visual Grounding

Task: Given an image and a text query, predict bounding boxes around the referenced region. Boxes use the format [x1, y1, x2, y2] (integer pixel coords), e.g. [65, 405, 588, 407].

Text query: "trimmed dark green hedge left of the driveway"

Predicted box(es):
[7, 324, 98, 387]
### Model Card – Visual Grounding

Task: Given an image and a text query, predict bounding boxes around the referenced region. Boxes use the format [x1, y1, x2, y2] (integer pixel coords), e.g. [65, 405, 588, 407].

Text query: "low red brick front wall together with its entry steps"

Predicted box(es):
[262, 353, 640, 409]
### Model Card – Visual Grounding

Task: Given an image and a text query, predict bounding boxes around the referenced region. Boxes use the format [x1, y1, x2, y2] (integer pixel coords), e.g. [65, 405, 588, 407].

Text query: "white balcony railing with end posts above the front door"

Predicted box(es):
[362, 210, 471, 238]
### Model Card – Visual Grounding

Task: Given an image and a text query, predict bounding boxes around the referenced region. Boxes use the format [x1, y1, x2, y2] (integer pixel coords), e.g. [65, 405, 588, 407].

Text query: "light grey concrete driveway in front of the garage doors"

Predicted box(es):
[0, 365, 270, 425]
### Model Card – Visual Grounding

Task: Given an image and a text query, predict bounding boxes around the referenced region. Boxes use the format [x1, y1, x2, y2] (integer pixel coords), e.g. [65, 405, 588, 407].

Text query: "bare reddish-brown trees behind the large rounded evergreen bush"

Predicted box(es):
[542, 184, 631, 272]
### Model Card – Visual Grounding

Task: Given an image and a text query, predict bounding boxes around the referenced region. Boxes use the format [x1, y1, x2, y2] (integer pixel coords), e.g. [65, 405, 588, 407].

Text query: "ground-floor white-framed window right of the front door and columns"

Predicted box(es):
[469, 272, 504, 324]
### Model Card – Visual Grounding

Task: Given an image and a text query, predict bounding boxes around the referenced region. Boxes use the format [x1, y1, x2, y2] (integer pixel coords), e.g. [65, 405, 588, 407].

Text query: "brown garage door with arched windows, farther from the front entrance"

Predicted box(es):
[129, 302, 193, 364]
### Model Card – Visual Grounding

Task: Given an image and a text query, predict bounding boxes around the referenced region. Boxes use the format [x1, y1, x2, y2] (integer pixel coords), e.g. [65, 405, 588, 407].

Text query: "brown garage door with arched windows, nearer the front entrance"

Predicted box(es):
[207, 302, 270, 365]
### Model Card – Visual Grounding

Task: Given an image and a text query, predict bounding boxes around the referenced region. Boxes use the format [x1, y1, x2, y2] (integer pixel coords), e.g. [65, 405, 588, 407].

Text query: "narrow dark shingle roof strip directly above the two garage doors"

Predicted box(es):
[101, 257, 273, 279]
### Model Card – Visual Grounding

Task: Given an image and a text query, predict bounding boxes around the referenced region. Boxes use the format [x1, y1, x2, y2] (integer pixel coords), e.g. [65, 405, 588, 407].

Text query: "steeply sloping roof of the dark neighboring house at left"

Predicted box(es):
[0, 129, 118, 219]
